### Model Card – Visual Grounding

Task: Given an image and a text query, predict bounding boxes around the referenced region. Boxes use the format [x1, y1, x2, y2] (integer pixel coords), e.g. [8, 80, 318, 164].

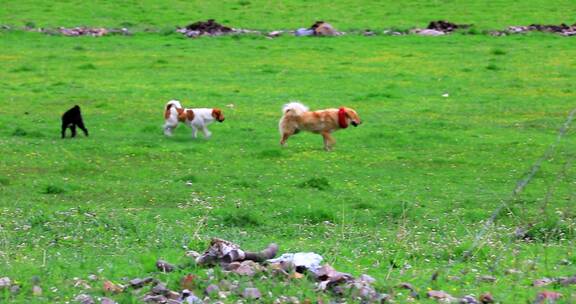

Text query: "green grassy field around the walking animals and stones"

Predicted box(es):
[0, 1, 576, 303]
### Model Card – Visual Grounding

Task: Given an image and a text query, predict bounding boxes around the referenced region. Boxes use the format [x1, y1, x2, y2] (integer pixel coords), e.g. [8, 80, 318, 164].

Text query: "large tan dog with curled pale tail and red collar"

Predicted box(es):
[279, 102, 362, 151]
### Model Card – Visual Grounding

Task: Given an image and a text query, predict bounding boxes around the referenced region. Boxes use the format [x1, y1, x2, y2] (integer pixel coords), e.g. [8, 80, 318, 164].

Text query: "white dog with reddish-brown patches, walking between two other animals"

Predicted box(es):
[164, 100, 224, 138]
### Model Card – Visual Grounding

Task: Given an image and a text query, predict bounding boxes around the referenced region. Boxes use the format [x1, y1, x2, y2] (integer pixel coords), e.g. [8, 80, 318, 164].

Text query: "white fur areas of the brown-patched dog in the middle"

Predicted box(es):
[164, 100, 223, 139]
